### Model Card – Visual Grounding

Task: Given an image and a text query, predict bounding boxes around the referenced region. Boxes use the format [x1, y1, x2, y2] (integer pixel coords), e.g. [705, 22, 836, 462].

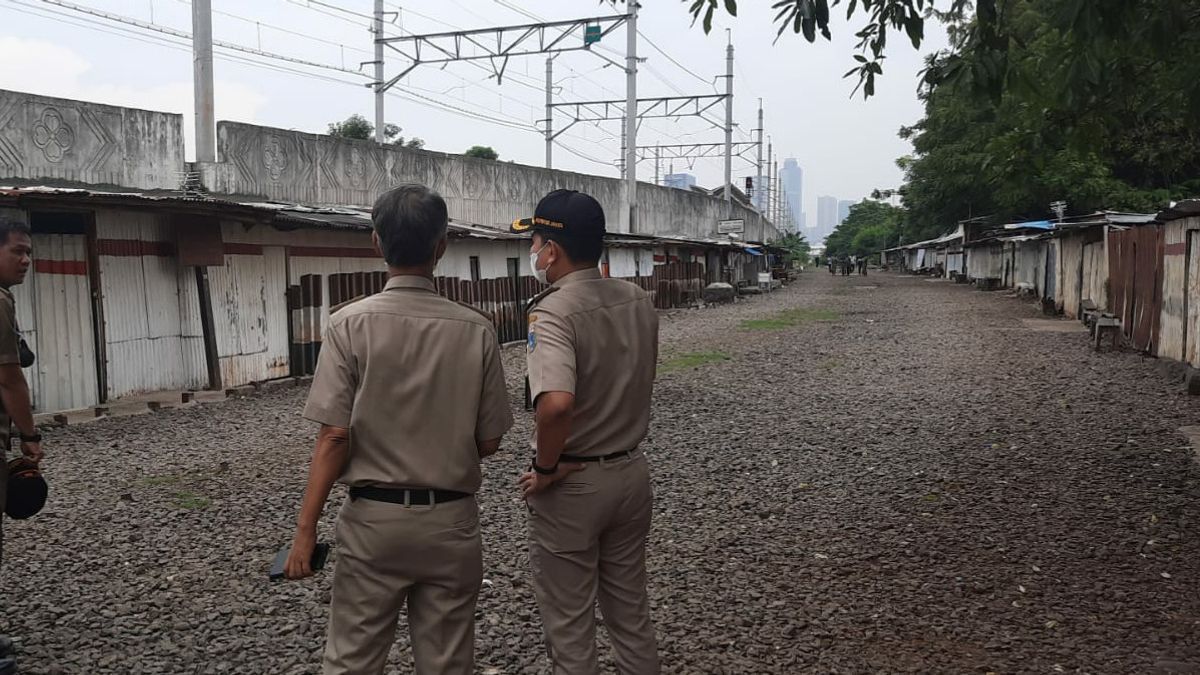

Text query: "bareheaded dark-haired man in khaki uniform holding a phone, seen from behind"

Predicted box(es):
[287, 185, 512, 675]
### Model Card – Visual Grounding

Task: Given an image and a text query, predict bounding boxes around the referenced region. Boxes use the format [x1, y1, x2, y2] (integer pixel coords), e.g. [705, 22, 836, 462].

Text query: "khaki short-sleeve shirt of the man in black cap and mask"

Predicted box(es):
[526, 269, 659, 456]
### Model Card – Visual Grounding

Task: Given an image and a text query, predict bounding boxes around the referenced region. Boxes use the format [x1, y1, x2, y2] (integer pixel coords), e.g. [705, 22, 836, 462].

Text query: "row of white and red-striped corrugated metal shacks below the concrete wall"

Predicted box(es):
[0, 186, 770, 412]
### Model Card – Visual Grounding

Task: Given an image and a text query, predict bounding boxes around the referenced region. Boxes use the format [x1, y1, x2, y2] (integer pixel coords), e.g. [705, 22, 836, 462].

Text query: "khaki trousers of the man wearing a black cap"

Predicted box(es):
[527, 453, 659, 675]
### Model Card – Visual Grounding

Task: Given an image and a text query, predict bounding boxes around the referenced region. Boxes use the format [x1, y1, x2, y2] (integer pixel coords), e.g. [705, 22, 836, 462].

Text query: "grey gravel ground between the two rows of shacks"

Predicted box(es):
[0, 271, 1200, 674]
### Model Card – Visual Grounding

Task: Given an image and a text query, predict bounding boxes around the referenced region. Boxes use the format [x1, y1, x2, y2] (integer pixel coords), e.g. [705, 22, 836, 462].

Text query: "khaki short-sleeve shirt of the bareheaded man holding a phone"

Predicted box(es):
[304, 276, 512, 492]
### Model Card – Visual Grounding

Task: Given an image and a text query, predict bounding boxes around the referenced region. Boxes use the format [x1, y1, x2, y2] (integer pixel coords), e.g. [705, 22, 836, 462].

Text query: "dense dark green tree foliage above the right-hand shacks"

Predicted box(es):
[899, 0, 1200, 234]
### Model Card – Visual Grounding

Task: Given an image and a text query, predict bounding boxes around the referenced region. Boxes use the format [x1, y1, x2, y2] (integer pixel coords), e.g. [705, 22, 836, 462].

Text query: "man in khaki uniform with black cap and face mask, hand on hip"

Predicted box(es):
[512, 190, 659, 675]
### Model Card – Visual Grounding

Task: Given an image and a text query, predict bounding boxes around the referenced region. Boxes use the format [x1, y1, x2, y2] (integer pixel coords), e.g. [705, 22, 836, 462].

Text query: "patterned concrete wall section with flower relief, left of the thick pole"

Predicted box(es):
[0, 90, 184, 189]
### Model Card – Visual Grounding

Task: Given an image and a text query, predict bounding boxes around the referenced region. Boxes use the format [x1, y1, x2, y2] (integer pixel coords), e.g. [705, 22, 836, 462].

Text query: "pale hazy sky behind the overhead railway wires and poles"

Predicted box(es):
[0, 0, 946, 225]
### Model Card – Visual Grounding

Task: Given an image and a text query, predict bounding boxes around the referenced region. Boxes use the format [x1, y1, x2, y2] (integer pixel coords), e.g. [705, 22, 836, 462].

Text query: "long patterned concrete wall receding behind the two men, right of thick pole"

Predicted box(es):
[202, 123, 778, 241]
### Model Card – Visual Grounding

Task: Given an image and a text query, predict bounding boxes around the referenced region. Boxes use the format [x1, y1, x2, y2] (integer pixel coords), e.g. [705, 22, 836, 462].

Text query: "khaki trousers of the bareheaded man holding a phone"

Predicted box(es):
[324, 487, 484, 675]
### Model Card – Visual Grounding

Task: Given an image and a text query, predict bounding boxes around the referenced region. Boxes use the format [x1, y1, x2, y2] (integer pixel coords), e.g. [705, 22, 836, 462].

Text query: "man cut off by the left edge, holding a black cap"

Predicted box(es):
[0, 216, 42, 675]
